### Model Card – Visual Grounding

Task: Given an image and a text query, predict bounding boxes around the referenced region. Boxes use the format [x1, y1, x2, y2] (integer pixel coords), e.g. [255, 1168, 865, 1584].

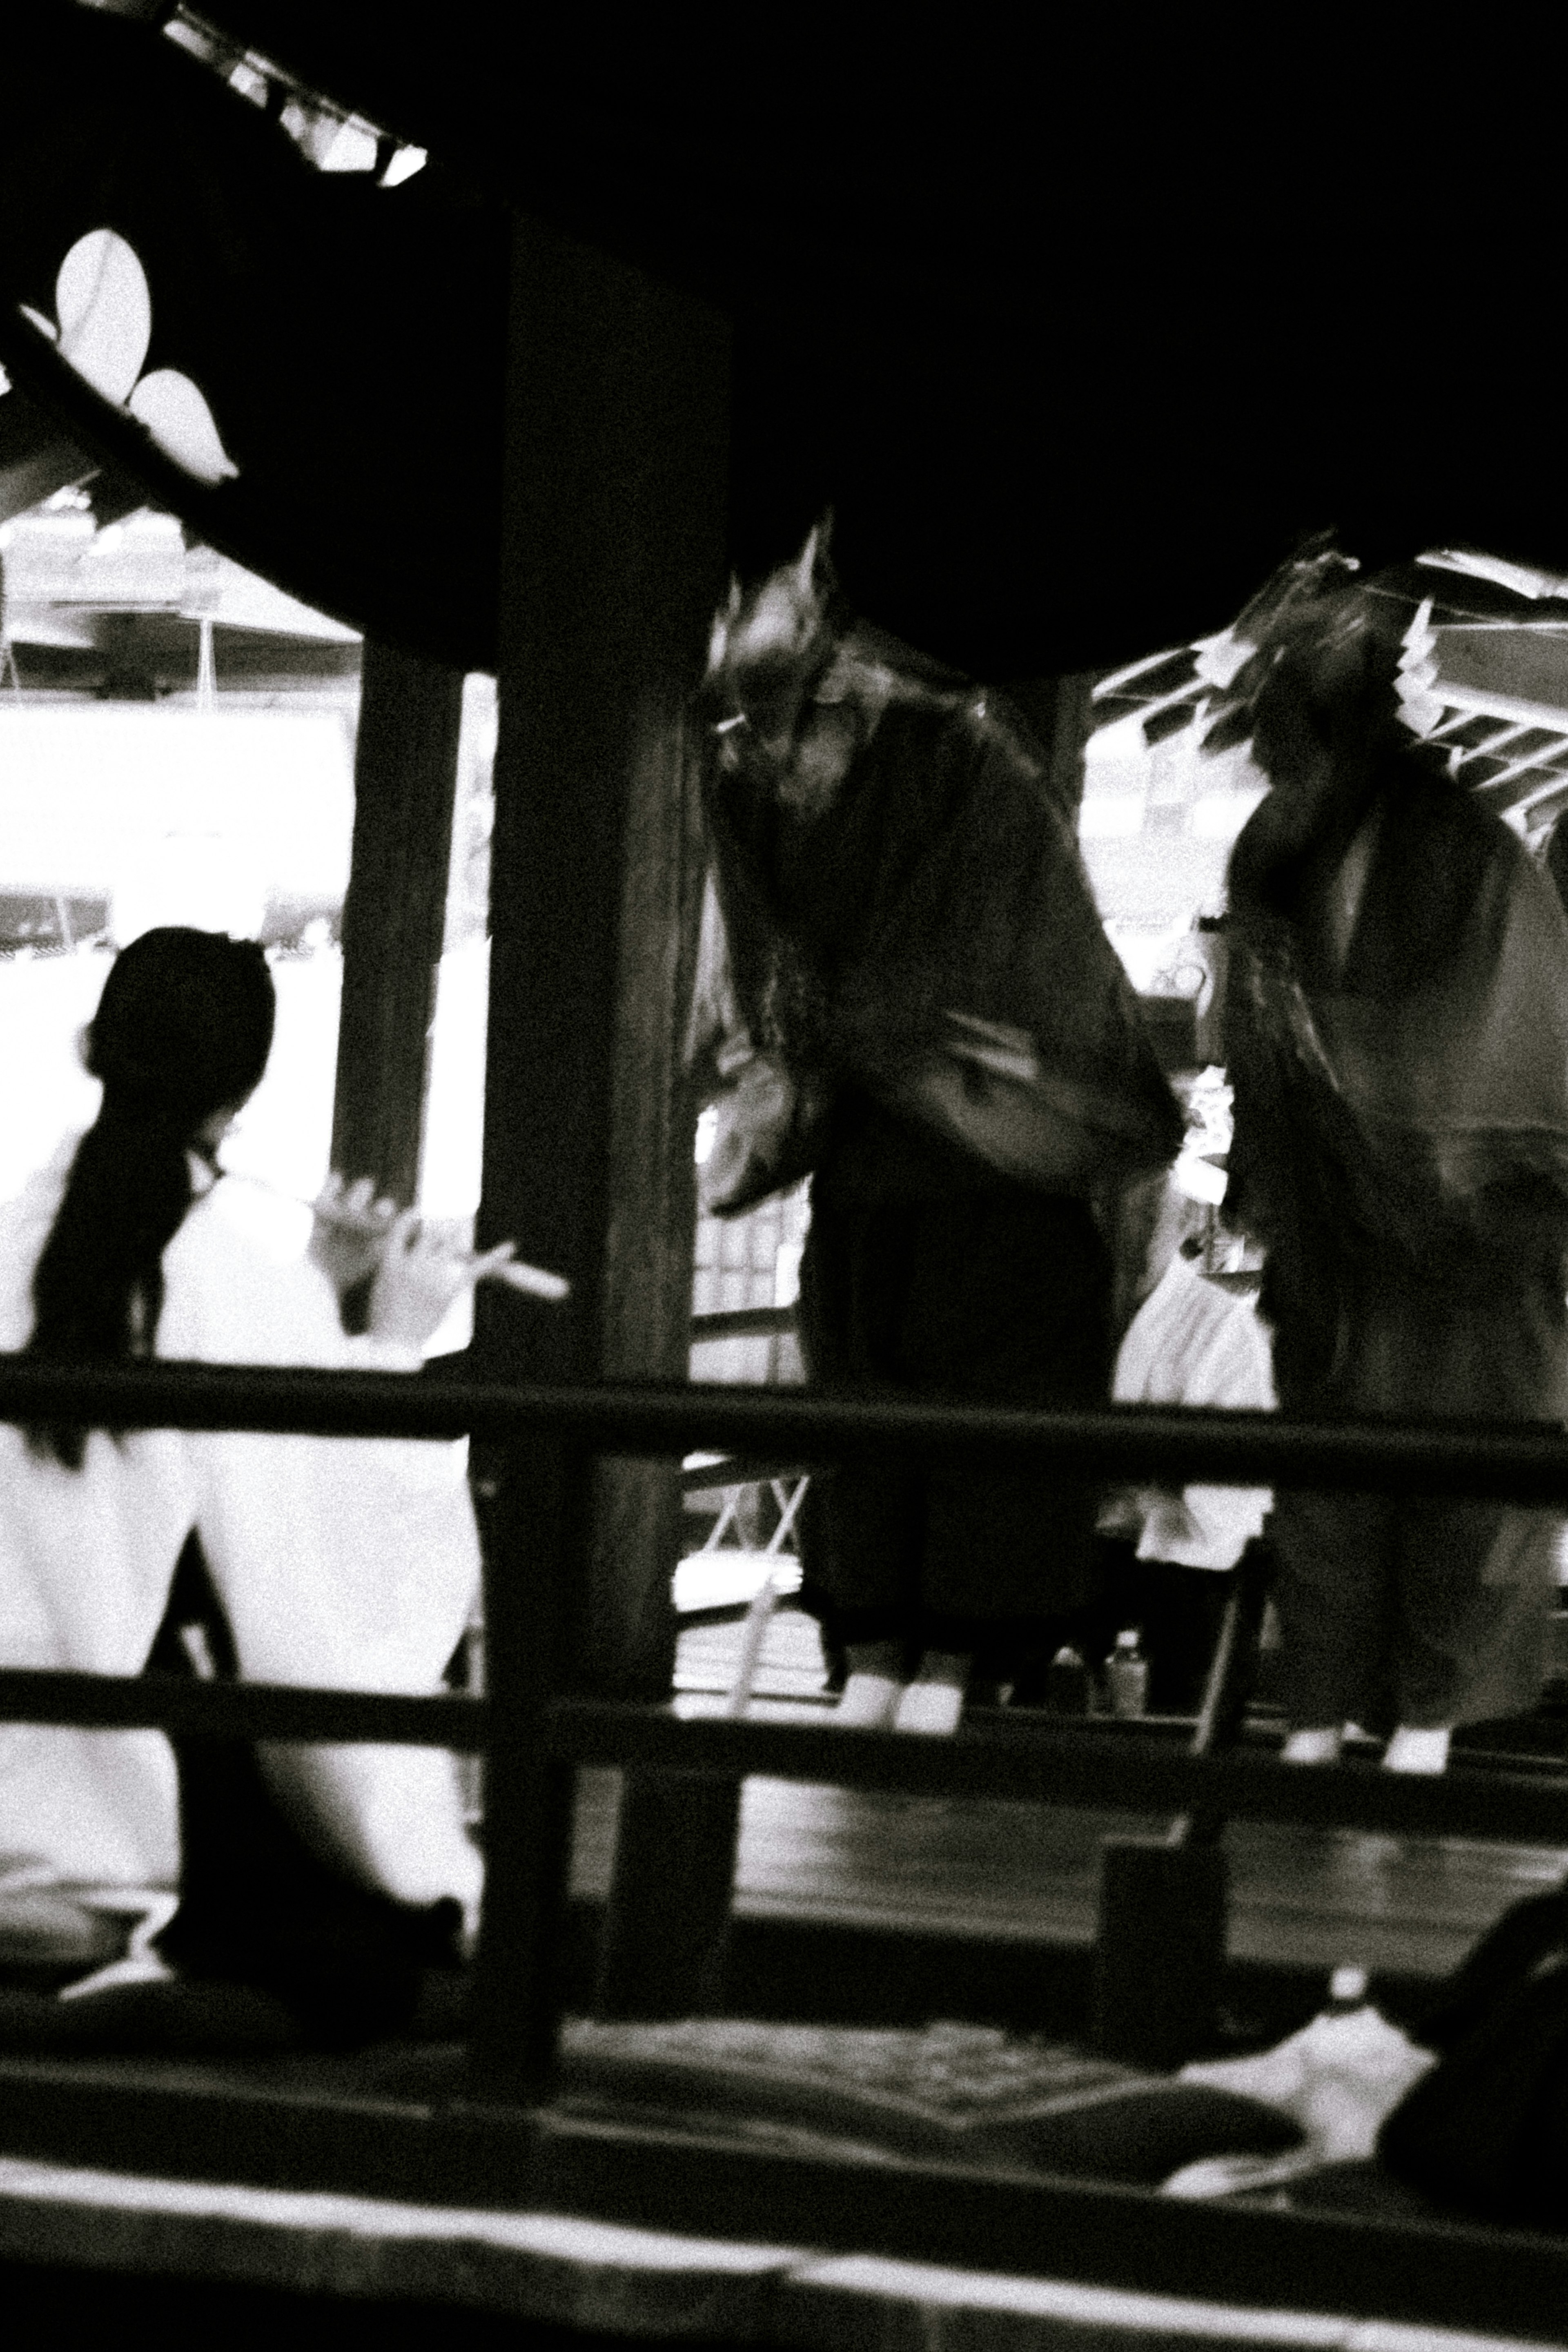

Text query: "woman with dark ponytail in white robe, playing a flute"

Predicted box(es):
[0, 929, 503, 1994]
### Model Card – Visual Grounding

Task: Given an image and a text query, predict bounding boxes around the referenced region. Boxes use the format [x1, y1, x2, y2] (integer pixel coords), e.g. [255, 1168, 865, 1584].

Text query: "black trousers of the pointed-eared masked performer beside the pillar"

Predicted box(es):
[799, 1178, 1112, 1679]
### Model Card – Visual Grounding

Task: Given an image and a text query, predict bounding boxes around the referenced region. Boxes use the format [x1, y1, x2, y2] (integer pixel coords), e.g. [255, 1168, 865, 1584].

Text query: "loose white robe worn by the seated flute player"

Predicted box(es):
[0, 1136, 482, 1912]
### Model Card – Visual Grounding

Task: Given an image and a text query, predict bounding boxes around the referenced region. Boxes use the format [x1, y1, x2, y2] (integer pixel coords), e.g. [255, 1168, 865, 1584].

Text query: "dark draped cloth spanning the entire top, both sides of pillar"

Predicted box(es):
[0, 0, 1568, 677]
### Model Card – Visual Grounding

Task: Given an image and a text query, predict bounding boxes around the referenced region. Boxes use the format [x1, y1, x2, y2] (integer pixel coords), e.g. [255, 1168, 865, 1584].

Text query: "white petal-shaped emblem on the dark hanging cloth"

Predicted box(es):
[21, 228, 240, 487]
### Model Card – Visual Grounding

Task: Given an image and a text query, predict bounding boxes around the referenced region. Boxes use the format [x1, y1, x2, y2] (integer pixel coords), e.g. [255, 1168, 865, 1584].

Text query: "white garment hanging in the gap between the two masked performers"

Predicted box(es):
[1100, 1251, 1279, 1569]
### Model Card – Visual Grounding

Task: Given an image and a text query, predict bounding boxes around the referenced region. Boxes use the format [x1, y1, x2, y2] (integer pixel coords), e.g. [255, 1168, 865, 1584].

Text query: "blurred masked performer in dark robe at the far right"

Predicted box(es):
[1208, 550, 1568, 1771]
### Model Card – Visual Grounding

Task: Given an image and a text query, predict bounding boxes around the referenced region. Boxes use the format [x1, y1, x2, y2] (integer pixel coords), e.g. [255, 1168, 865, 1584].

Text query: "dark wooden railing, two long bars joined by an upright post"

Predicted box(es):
[0, 1357, 1568, 2060]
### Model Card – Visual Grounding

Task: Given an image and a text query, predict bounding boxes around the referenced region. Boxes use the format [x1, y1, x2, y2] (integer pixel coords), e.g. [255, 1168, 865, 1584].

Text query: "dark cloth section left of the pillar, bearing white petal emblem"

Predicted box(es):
[0, 9, 508, 670]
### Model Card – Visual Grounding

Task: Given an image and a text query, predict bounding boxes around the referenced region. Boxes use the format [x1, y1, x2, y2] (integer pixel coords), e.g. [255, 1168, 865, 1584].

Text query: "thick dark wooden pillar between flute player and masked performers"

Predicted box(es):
[472, 221, 729, 2096]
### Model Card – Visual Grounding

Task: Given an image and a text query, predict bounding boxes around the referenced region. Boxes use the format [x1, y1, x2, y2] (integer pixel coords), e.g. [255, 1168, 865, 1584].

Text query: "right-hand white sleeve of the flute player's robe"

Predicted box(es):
[160, 1197, 479, 1907]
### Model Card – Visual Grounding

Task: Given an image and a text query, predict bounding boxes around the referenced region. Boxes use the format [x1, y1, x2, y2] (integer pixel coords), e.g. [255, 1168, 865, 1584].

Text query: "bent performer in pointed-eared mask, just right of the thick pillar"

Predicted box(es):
[691, 529, 1183, 1731]
